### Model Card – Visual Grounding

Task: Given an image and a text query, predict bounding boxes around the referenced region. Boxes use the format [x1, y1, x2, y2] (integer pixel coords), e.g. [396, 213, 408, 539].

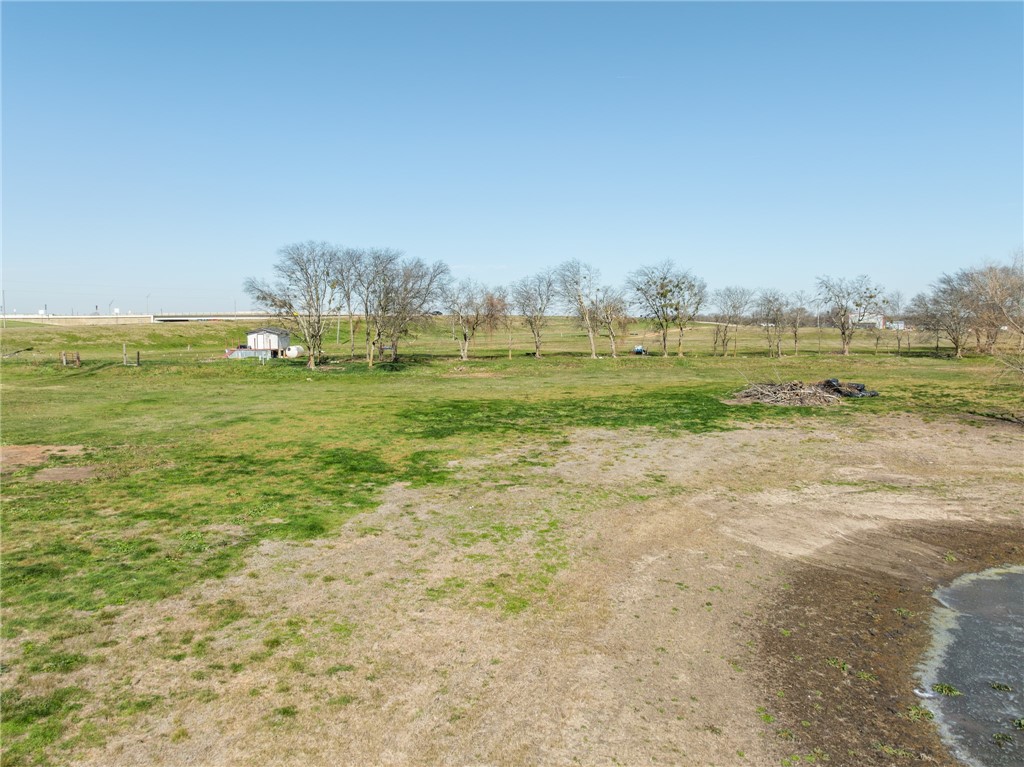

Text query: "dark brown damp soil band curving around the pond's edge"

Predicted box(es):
[760, 523, 1024, 767]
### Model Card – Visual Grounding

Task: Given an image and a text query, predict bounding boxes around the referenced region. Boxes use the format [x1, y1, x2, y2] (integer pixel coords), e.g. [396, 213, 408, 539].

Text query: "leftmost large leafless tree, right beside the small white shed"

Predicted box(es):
[243, 241, 339, 370]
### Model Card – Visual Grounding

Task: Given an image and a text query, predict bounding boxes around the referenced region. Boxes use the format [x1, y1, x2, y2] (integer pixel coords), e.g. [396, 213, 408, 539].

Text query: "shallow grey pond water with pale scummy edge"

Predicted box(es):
[919, 567, 1024, 767]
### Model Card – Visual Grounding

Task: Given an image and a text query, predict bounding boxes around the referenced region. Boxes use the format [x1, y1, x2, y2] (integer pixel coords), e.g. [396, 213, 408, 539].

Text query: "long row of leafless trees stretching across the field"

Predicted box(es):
[245, 242, 1024, 368]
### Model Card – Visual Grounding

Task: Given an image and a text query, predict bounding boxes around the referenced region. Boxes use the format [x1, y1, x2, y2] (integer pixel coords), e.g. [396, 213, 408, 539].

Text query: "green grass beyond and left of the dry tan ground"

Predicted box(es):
[0, 321, 1020, 764]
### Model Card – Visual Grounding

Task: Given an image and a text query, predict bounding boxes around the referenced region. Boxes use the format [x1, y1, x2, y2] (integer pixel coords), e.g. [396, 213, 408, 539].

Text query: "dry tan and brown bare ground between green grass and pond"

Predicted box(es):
[8, 417, 1024, 767]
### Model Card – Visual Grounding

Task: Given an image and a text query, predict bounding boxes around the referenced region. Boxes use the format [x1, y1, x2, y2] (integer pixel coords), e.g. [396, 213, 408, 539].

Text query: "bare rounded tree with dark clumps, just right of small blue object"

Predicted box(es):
[627, 261, 708, 356]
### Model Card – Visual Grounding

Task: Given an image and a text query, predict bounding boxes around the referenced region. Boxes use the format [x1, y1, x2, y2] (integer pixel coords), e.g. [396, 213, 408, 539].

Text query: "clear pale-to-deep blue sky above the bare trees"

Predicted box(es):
[0, 2, 1024, 313]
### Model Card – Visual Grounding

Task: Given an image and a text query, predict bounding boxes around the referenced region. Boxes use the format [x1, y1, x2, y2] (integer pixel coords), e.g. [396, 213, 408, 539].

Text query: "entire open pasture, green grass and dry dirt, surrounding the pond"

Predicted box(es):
[0, 319, 1024, 765]
